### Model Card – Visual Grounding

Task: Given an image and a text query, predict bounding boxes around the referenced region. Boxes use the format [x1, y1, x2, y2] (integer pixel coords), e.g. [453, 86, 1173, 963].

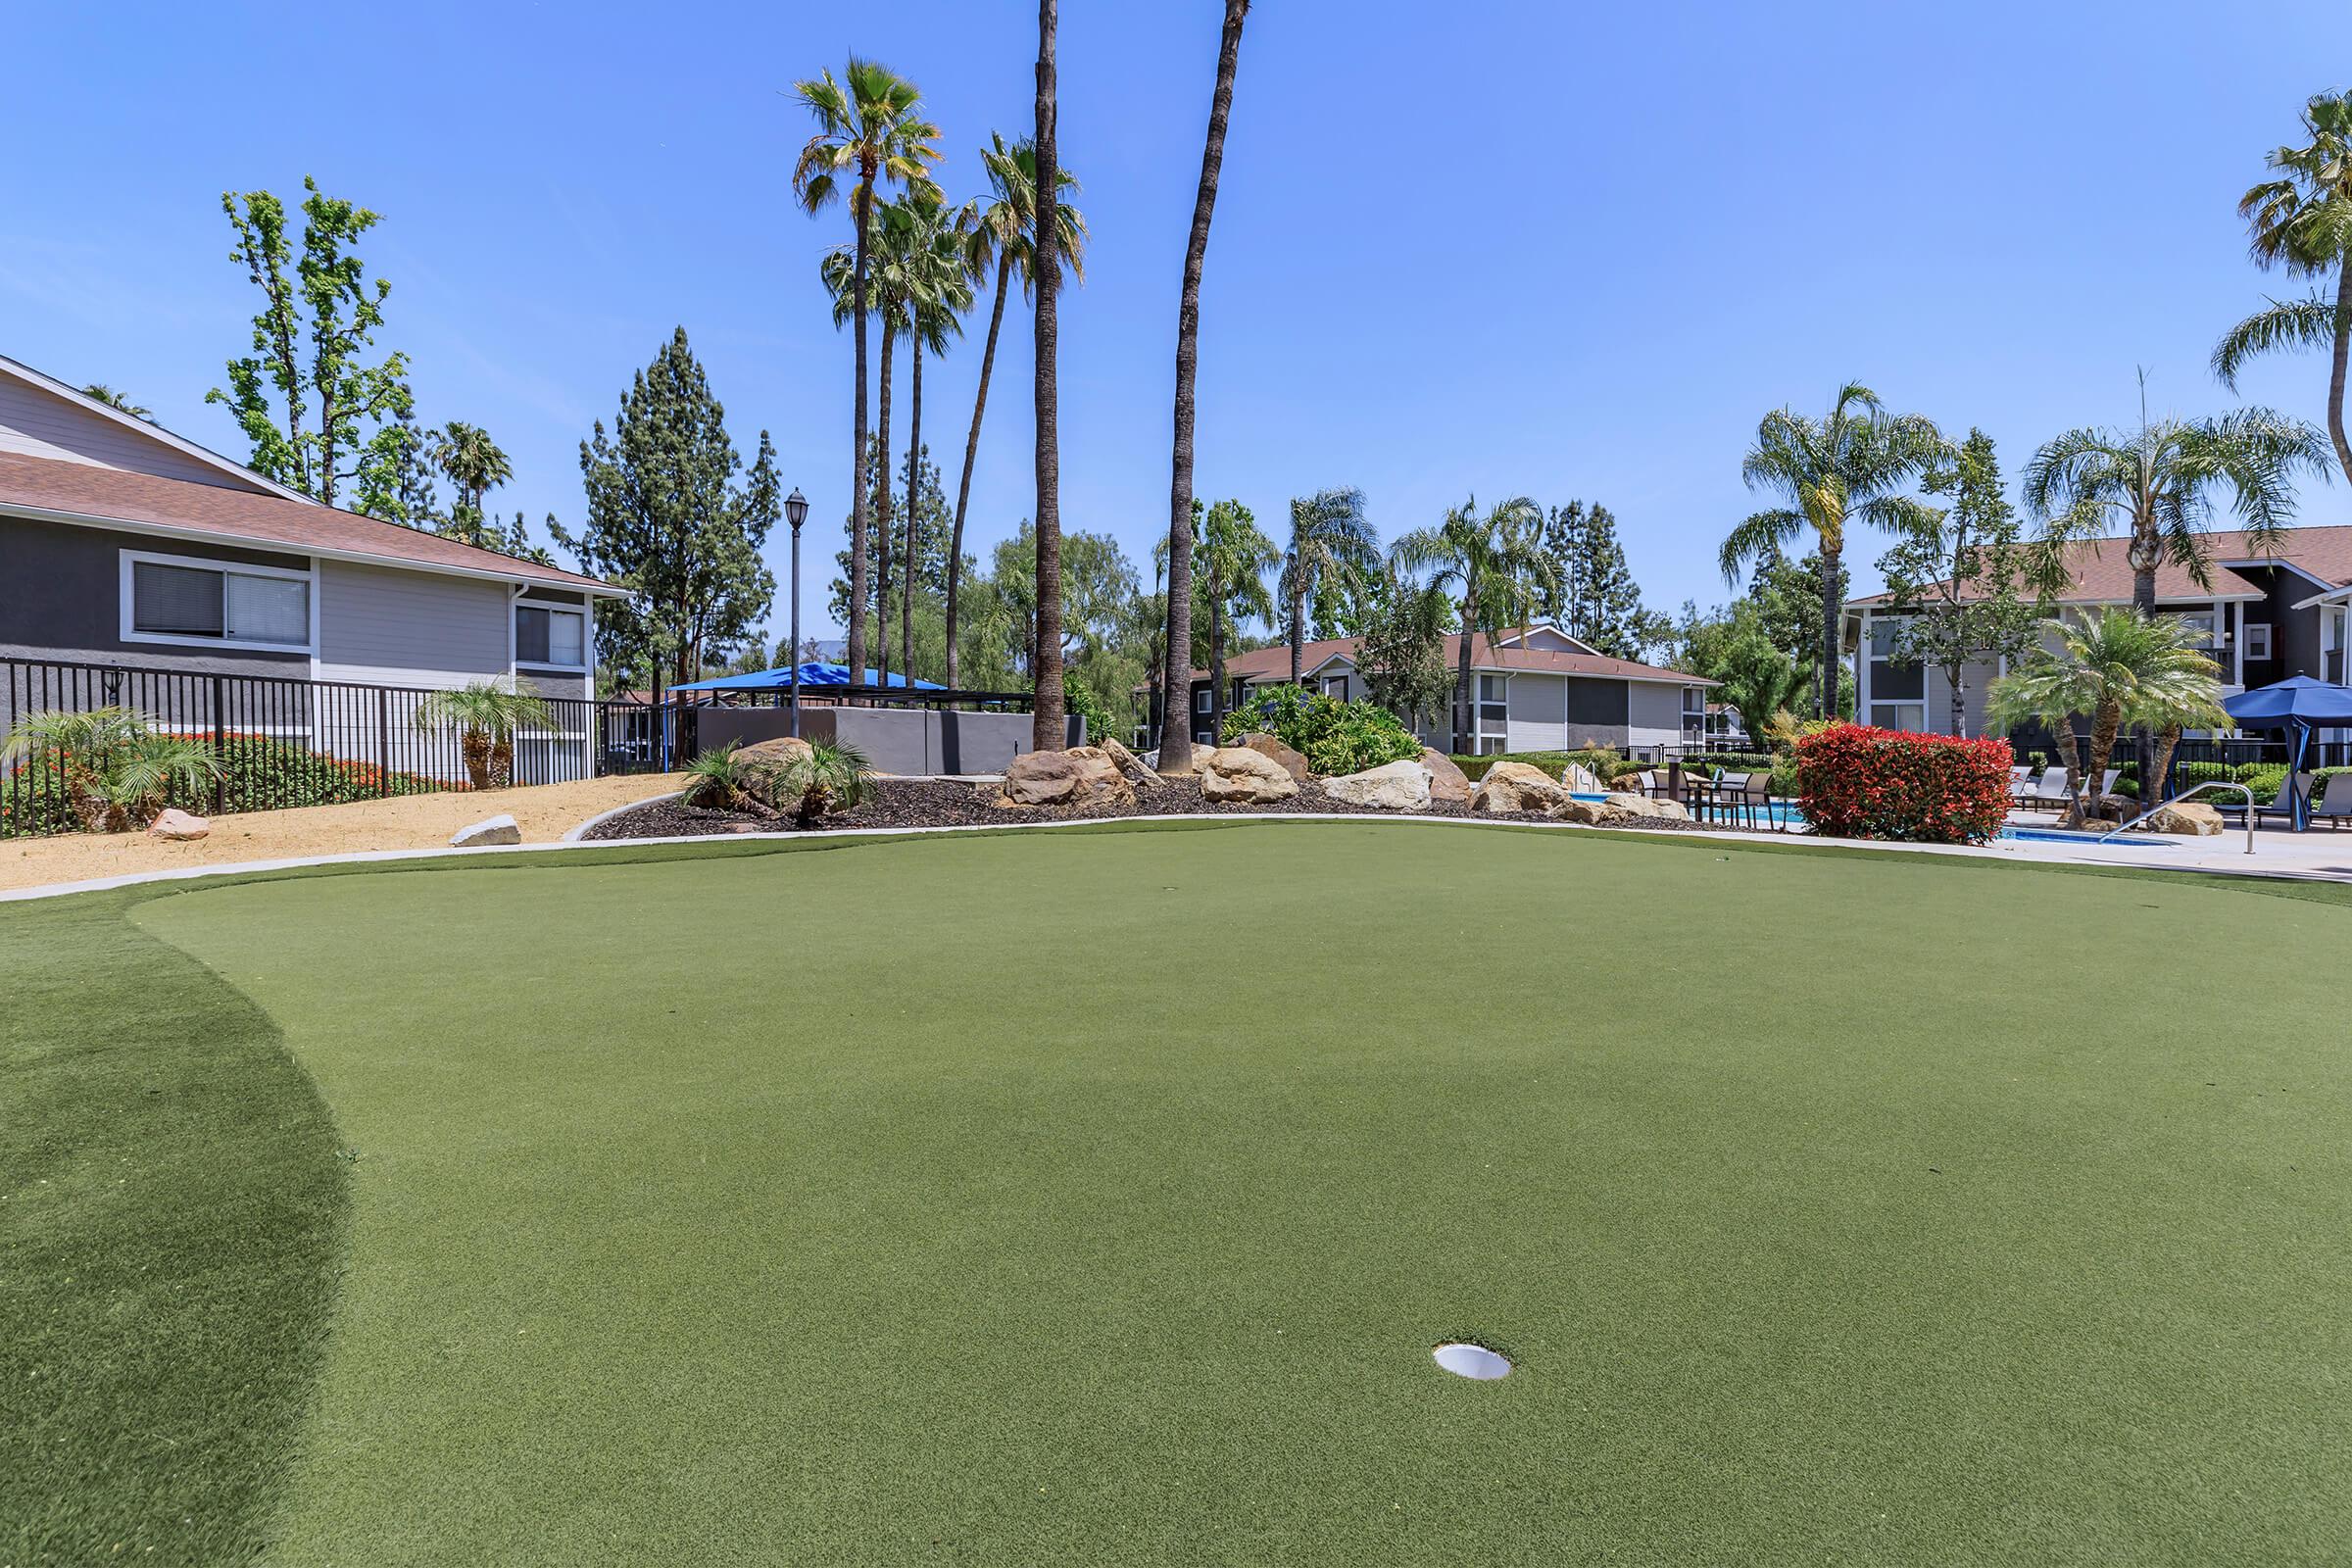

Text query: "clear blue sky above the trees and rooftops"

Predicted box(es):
[14, 0, 2352, 644]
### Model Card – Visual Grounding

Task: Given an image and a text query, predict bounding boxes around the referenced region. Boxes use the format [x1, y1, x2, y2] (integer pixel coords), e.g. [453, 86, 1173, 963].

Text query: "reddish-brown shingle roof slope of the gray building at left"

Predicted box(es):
[0, 454, 618, 592]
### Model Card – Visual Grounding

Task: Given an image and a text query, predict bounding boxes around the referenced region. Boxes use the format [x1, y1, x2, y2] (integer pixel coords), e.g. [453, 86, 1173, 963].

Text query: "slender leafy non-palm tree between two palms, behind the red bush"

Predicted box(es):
[1880, 430, 2056, 736]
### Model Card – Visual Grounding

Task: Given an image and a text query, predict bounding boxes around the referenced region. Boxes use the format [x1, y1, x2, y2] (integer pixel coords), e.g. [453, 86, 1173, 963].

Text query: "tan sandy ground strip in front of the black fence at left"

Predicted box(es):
[0, 773, 684, 889]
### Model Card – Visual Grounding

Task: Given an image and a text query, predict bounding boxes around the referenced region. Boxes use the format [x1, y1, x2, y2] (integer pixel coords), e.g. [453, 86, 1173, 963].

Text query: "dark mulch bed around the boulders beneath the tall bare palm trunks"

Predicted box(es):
[586, 778, 1698, 839]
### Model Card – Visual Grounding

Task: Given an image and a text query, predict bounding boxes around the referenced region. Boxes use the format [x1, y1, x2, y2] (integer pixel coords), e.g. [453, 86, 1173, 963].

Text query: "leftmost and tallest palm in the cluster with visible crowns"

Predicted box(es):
[793, 54, 939, 700]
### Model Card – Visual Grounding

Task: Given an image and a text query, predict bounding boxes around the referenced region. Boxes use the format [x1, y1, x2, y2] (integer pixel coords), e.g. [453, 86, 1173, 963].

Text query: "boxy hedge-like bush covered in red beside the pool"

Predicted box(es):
[1797, 724, 2011, 844]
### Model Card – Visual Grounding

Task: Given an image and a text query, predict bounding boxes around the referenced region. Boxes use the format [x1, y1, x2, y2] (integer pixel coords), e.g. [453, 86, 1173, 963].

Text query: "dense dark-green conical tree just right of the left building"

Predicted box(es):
[548, 326, 783, 684]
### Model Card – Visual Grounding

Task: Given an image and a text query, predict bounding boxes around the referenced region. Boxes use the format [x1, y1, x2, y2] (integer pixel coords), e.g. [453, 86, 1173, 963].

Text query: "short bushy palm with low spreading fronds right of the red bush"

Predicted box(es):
[1985, 607, 2228, 823]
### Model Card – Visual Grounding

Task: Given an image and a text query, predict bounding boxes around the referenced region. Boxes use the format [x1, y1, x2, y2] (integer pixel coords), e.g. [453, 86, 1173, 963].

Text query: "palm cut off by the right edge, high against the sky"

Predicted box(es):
[2213, 92, 2352, 479]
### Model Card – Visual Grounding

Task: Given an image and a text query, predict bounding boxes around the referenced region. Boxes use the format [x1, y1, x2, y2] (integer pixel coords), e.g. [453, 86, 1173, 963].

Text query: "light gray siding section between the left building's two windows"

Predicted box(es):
[318, 562, 515, 686]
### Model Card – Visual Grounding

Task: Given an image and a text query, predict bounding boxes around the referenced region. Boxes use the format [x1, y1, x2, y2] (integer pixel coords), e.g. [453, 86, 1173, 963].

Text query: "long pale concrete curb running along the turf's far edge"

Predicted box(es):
[0, 797, 2352, 903]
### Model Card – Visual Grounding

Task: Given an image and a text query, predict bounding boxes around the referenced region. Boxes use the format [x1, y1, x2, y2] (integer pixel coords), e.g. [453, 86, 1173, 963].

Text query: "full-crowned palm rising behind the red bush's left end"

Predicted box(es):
[1719, 381, 1945, 717]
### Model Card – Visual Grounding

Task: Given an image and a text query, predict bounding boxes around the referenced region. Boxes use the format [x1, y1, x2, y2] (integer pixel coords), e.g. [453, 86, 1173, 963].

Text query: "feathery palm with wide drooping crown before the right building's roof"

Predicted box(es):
[2021, 371, 2327, 615]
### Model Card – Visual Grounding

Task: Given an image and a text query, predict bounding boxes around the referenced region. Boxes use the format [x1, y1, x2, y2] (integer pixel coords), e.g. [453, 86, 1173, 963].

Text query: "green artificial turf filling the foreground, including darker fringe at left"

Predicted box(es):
[14, 823, 2352, 1563]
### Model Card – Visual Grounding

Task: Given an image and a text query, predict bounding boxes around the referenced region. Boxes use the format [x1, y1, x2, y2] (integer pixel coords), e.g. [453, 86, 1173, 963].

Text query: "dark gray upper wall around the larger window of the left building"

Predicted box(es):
[0, 510, 311, 677]
